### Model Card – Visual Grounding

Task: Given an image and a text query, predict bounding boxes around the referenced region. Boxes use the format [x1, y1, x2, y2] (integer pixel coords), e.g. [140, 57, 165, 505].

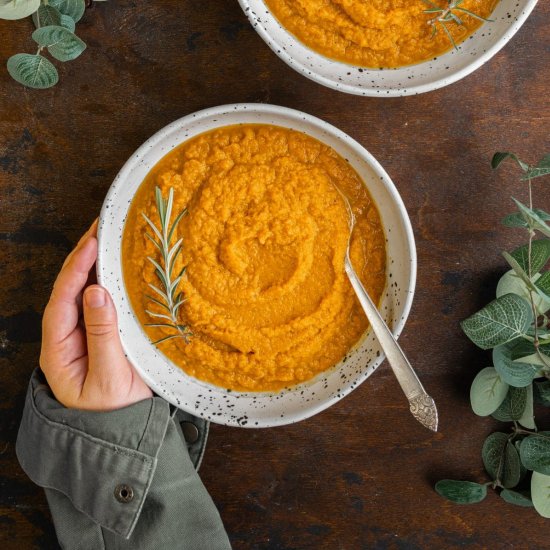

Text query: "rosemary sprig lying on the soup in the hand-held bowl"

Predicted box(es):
[141, 187, 192, 344]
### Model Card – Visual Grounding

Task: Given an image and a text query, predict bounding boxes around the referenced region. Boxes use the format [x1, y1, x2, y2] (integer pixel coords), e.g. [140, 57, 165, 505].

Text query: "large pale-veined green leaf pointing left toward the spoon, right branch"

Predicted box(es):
[461, 294, 533, 349]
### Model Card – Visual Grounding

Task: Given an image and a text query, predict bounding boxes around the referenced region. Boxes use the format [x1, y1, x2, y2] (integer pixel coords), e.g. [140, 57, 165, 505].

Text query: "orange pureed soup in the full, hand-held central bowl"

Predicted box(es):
[122, 124, 386, 391]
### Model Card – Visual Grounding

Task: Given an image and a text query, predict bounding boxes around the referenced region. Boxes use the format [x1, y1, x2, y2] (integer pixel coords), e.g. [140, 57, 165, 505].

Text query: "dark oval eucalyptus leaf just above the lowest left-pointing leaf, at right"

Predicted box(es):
[481, 432, 521, 488]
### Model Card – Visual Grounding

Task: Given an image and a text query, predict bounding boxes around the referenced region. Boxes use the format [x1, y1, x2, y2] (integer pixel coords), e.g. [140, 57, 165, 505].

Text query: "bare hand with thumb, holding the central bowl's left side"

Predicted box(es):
[40, 220, 153, 411]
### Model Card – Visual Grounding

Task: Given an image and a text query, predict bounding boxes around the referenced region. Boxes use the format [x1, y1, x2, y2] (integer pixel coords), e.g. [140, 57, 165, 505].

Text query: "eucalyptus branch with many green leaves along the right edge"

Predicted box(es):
[435, 152, 550, 517]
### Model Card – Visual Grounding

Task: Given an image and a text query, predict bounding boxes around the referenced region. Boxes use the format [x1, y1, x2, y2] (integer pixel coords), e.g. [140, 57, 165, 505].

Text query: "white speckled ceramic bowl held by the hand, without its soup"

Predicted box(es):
[97, 103, 416, 428]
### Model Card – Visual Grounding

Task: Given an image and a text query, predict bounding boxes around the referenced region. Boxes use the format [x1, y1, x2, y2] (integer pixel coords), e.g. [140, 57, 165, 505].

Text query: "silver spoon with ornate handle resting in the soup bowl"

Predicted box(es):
[335, 186, 438, 432]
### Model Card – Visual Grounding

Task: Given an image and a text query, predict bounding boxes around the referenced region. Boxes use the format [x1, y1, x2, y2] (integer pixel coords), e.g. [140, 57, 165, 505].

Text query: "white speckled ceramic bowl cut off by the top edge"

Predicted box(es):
[239, 0, 537, 97]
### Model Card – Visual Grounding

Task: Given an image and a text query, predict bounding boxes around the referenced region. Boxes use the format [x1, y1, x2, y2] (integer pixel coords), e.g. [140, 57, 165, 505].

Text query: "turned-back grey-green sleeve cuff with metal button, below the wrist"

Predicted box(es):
[16, 371, 171, 538]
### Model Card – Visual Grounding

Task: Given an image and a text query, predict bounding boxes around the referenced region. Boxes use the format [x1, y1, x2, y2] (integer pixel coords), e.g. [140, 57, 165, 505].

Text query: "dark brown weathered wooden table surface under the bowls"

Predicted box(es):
[0, 0, 550, 550]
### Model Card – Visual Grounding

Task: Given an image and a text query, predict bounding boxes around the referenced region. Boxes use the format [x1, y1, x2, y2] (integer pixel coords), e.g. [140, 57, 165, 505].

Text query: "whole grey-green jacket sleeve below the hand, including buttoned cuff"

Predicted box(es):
[16, 369, 230, 550]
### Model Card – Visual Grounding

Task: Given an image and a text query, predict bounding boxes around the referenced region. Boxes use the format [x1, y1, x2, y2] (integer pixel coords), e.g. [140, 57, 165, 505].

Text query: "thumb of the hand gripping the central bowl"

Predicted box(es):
[83, 285, 127, 374]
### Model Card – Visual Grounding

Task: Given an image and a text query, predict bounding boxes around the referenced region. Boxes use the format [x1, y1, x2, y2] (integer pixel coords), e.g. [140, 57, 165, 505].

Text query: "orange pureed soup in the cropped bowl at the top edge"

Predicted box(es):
[265, 0, 498, 68]
